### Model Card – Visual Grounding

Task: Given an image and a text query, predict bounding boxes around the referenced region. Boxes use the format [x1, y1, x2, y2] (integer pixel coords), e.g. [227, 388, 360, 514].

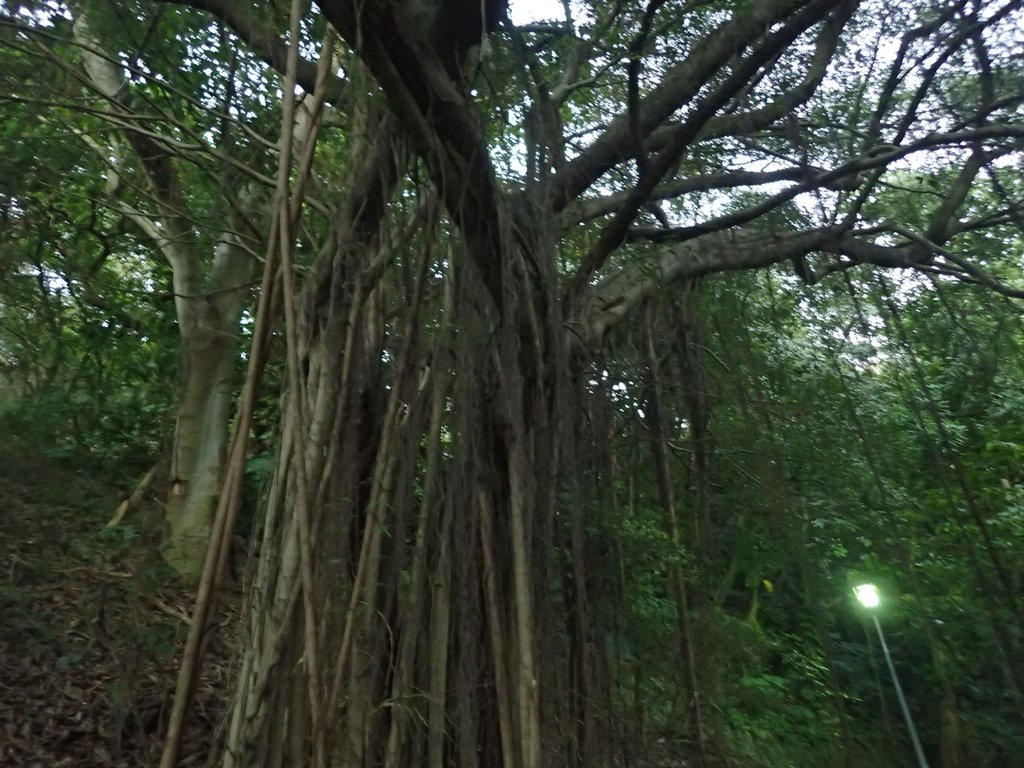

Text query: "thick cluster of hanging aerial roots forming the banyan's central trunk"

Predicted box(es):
[223, 137, 567, 768]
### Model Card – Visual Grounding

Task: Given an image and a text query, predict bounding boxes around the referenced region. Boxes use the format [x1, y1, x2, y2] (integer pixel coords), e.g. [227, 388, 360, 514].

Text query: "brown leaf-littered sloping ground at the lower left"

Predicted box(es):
[0, 444, 238, 768]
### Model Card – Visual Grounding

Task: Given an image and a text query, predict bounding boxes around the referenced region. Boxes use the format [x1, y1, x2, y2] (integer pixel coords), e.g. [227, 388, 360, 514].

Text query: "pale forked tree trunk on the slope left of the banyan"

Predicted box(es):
[75, 11, 259, 581]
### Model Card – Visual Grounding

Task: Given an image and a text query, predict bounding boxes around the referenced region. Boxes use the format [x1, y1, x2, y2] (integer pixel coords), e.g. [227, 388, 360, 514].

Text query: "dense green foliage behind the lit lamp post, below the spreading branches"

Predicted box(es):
[595, 264, 1024, 767]
